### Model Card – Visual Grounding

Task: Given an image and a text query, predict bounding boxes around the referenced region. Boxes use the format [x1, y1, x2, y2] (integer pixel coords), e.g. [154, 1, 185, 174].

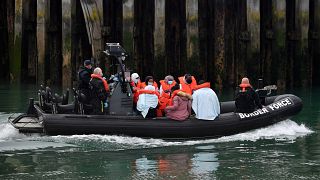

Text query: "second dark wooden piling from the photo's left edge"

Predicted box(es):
[21, 0, 38, 83]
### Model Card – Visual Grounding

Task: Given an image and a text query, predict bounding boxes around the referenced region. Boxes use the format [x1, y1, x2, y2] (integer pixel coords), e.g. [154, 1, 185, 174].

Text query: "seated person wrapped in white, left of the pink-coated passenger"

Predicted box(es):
[137, 85, 159, 118]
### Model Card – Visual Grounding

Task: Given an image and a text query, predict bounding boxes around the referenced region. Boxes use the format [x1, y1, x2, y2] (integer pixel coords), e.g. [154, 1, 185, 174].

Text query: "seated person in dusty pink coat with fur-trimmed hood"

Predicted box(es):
[164, 84, 192, 121]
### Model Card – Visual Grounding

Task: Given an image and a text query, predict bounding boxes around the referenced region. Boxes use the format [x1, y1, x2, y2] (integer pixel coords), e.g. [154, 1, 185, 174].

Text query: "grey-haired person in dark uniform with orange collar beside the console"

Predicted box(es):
[89, 68, 109, 114]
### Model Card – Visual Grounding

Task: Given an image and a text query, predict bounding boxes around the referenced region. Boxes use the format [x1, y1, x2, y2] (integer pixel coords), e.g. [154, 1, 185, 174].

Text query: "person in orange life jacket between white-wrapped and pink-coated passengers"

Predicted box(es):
[157, 75, 177, 117]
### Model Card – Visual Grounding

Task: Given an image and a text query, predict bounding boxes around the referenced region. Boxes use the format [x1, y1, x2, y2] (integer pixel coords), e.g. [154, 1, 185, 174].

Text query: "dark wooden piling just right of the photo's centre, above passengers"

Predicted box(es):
[165, 0, 187, 77]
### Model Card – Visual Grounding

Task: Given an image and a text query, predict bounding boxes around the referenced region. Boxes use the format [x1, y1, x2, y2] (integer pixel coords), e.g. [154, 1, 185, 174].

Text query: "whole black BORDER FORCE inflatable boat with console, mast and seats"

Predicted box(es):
[8, 43, 302, 139]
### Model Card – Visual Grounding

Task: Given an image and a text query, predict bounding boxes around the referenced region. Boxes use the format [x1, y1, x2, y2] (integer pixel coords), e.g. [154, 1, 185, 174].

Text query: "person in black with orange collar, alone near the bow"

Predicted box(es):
[235, 78, 262, 113]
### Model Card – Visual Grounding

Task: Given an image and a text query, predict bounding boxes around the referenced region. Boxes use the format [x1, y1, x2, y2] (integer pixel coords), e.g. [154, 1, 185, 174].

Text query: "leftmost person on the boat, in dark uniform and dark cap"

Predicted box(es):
[78, 60, 92, 102]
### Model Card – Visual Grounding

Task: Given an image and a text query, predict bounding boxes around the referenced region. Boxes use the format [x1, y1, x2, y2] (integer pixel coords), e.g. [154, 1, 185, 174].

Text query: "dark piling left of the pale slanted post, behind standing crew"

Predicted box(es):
[71, 0, 92, 87]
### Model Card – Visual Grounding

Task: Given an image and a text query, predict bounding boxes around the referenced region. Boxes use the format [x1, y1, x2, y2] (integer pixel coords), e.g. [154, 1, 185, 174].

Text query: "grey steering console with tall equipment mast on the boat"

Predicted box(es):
[103, 43, 133, 115]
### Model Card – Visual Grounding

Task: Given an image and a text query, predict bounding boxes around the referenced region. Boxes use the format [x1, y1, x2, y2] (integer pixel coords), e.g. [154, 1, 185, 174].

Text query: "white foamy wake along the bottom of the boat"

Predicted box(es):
[0, 120, 313, 151]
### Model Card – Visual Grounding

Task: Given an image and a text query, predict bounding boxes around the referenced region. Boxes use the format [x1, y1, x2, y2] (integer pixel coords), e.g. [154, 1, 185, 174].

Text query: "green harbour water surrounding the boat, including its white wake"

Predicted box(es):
[0, 85, 320, 179]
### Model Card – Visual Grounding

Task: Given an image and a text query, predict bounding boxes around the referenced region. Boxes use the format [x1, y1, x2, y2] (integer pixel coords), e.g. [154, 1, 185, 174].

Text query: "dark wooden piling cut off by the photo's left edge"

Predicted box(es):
[0, 0, 9, 81]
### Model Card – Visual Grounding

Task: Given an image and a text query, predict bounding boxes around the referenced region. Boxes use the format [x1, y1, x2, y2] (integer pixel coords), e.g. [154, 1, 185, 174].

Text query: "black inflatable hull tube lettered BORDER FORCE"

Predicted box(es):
[32, 95, 302, 139]
